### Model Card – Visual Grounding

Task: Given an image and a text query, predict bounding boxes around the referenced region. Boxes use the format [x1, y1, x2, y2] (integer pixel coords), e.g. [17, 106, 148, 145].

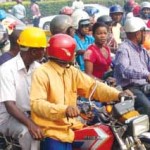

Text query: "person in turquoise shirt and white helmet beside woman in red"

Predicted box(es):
[72, 10, 94, 71]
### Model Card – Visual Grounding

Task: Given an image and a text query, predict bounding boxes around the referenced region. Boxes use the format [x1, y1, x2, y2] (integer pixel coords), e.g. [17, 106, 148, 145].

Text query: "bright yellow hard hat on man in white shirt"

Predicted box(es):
[17, 27, 47, 48]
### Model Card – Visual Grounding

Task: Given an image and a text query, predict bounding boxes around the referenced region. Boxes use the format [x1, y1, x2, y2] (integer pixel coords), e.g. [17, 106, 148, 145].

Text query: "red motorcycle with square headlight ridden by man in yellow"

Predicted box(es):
[73, 82, 150, 150]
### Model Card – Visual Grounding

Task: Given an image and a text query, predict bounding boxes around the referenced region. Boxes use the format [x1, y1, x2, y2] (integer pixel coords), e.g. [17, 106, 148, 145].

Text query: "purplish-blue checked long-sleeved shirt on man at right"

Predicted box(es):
[114, 40, 150, 87]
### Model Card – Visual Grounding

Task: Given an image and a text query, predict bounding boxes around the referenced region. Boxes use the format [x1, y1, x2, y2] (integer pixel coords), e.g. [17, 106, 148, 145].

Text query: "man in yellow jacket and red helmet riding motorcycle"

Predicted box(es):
[30, 34, 133, 150]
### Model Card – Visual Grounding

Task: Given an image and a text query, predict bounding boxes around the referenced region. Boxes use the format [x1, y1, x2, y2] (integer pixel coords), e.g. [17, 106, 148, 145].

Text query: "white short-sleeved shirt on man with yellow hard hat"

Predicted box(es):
[0, 53, 40, 124]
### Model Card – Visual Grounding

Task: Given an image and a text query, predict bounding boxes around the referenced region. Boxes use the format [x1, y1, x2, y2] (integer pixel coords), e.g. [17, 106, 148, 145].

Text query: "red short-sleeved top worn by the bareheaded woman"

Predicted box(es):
[84, 44, 111, 78]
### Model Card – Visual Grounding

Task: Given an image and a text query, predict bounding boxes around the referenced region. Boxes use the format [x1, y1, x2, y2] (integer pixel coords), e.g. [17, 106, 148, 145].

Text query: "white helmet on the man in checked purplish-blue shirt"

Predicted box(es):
[124, 17, 147, 32]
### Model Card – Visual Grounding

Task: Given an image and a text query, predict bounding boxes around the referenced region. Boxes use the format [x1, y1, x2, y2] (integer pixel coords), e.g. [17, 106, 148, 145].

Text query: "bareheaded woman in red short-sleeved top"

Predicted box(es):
[84, 22, 111, 79]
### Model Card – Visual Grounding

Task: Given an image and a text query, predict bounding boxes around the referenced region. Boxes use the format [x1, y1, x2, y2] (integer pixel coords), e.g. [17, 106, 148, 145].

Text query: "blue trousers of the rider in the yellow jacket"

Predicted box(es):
[40, 138, 72, 150]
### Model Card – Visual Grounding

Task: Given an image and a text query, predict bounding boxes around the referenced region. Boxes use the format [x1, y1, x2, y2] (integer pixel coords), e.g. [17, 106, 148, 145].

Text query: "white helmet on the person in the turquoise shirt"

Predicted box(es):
[71, 9, 90, 29]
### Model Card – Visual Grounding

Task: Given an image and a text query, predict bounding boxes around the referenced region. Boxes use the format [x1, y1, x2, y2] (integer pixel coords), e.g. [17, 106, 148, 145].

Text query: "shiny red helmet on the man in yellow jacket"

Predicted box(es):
[47, 34, 76, 63]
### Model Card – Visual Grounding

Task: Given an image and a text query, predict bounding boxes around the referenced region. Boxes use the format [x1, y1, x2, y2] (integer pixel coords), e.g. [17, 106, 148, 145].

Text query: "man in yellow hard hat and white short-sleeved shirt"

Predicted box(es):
[0, 27, 47, 150]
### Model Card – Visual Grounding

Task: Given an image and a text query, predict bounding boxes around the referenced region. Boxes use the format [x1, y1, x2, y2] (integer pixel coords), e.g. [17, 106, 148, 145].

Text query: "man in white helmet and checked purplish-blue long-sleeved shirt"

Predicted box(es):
[114, 17, 150, 115]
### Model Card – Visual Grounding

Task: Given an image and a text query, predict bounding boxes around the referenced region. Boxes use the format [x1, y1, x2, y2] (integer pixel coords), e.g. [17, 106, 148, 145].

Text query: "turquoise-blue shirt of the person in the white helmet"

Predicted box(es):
[74, 34, 94, 71]
